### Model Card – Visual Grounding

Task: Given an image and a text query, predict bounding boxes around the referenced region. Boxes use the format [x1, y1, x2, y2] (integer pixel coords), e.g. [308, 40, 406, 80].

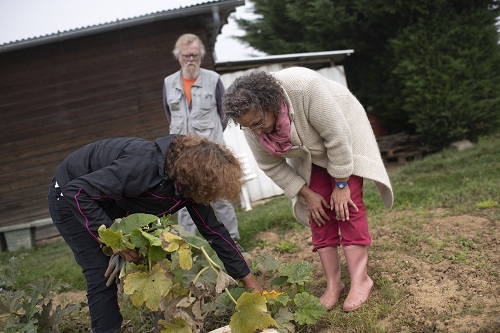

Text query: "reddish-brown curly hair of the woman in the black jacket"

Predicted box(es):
[166, 134, 243, 204]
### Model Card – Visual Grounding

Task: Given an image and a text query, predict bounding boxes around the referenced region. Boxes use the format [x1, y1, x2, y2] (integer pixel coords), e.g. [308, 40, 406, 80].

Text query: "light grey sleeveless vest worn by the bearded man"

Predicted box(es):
[164, 68, 224, 143]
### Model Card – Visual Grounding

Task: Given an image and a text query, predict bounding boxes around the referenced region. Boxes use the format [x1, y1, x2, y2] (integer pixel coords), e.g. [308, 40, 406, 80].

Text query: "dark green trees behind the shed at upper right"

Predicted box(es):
[237, 0, 500, 147]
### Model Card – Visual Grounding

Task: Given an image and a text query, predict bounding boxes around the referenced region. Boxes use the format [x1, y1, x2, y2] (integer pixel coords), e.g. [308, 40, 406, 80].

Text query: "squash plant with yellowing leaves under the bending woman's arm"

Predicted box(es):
[99, 214, 326, 333]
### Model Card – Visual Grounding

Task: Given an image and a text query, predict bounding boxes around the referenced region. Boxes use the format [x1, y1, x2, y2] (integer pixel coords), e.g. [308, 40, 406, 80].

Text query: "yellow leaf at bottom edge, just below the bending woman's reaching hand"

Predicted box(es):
[229, 292, 278, 333]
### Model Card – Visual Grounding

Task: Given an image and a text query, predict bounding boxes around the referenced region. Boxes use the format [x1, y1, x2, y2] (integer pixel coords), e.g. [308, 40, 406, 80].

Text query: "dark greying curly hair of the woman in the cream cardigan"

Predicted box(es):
[222, 71, 286, 120]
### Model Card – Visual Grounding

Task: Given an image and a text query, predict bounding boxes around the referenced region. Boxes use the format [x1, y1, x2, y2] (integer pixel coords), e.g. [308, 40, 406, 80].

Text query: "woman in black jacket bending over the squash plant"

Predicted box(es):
[48, 135, 262, 333]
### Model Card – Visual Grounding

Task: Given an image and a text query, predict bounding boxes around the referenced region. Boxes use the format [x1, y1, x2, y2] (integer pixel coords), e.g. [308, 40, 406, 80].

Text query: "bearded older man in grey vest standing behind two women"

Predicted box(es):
[163, 34, 243, 252]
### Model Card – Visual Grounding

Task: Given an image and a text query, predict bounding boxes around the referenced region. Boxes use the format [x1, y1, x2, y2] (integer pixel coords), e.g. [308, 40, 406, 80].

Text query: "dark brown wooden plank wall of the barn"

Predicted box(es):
[0, 17, 213, 226]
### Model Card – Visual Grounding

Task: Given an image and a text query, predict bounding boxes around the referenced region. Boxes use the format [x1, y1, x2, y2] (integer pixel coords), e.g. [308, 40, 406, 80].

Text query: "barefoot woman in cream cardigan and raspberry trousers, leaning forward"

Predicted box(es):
[223, 67, 394, 311]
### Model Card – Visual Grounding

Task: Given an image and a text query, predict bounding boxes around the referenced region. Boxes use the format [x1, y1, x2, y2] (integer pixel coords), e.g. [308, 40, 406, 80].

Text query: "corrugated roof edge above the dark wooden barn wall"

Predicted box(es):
[0, 0, 245, 53]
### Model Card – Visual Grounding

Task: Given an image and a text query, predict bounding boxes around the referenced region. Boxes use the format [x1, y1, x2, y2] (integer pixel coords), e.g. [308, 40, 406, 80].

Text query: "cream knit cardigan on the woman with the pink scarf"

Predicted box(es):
[245, 67, 394, 226]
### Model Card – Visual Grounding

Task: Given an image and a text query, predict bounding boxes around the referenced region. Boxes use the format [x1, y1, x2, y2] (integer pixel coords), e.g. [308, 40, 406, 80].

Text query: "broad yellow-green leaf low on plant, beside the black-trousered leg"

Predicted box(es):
[123, 264, 172, 311]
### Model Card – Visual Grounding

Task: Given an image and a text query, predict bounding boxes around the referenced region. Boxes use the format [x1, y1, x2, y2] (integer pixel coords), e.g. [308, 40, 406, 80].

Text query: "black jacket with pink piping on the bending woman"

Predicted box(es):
[55, 135, 250, 279]
